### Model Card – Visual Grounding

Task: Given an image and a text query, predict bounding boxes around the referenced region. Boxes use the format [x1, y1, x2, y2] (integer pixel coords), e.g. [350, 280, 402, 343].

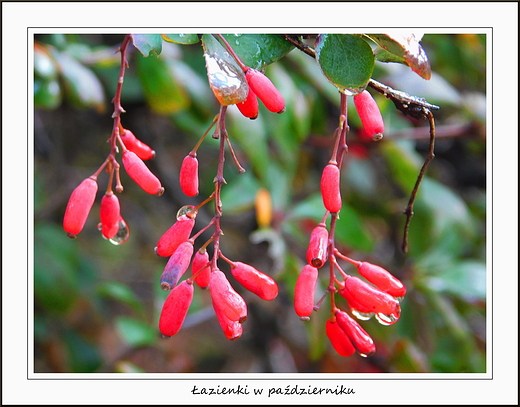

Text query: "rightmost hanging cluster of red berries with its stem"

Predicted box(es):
[294, 90, 406, 356]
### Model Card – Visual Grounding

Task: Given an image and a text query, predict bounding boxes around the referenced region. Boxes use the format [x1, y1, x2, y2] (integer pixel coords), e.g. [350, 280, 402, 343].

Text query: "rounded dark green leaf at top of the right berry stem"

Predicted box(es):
[316, 34, 375, 93]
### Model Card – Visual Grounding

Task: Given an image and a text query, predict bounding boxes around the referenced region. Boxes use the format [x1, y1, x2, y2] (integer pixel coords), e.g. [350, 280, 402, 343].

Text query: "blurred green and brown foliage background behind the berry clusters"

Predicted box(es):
[34, 34, 488, 373]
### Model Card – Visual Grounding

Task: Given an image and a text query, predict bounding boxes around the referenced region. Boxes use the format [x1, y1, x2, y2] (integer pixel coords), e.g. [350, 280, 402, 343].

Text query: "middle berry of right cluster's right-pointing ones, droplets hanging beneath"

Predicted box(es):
[339, 277, 401, 322]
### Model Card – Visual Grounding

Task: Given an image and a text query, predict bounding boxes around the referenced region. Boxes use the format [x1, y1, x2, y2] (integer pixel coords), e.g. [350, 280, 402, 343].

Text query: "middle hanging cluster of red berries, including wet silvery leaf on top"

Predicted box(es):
[155, 37, 285, 340]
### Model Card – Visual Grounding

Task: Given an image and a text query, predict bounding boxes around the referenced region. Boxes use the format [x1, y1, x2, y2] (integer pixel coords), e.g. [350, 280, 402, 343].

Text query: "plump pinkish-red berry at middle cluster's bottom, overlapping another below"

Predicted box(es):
[209, 269, 247, 323]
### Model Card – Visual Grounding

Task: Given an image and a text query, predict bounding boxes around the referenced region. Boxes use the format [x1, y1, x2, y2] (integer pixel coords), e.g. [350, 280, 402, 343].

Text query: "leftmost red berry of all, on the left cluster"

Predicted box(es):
[63, 178, 98, 238]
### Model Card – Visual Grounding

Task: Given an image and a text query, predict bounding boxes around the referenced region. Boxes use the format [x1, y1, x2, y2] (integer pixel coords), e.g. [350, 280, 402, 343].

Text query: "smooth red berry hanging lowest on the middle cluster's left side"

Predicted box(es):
[159, 280, 193, 336]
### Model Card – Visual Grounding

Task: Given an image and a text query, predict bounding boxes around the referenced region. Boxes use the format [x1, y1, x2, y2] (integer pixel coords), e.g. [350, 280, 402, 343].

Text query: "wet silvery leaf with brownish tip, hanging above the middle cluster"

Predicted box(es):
[202, 34, 249, 106]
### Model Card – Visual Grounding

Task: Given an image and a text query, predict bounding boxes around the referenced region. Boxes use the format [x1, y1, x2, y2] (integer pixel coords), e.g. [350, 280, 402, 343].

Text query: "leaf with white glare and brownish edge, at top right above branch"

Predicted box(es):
[367, 33, 432, 79]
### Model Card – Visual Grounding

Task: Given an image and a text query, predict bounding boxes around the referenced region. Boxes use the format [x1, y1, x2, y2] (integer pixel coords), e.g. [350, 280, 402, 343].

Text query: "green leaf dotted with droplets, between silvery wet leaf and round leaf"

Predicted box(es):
[218, 34, 294, 70]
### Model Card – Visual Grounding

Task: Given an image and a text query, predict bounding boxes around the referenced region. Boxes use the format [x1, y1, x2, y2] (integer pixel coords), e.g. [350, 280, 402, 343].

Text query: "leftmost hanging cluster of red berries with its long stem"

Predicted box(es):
[63, 35, 164, 245]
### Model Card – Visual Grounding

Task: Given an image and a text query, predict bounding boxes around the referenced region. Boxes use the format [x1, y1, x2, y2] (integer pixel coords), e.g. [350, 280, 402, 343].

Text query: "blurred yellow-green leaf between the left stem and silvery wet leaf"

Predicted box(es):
[137, 51, 190, 114]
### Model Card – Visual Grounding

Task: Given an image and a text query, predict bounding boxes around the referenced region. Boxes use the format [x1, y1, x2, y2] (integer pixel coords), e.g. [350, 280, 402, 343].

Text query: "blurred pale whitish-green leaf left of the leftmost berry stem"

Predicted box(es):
[52, 50, 106, 112]
